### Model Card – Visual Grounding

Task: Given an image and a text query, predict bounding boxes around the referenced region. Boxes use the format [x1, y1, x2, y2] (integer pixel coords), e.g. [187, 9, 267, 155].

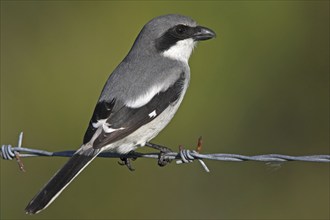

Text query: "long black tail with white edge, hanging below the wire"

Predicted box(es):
[25, 150, 97, 214]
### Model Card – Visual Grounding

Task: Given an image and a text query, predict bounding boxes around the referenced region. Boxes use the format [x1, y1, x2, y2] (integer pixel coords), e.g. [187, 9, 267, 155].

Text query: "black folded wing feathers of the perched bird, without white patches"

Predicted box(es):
[84, 73, 185, 148]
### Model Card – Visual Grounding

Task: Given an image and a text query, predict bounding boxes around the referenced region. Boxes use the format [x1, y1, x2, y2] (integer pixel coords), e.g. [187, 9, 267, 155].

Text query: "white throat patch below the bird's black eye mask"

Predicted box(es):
[163, 38, 196, 63]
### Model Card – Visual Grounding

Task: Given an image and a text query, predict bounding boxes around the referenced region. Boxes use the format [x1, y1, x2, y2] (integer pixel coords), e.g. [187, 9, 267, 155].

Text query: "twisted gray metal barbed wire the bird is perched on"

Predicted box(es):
[0, 132, 330, 172]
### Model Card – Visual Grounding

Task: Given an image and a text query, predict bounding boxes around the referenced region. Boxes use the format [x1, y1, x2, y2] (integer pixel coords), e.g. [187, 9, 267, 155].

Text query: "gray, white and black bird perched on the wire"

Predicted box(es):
[25, 14, 215, 214]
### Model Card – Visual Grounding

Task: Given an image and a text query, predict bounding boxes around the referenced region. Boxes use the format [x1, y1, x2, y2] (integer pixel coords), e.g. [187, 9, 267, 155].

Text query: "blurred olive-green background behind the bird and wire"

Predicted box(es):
[0, 1, 330, 219]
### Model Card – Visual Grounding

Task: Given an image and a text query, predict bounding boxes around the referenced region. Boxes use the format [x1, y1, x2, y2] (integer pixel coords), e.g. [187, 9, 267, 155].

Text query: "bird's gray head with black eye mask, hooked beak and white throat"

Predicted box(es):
[129, 14, 216, 63]
